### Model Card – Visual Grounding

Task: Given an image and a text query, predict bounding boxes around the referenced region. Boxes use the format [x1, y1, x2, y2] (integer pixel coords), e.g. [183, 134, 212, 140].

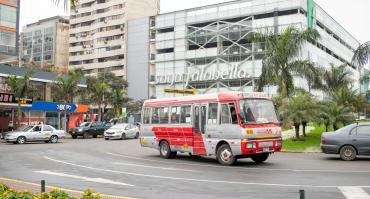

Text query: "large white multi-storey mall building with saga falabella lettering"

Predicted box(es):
[149, 0, 360, 98]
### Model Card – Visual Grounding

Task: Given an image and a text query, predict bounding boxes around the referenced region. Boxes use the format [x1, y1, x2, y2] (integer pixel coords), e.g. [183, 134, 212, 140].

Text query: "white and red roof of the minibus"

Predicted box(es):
[144, 91, 270, 106]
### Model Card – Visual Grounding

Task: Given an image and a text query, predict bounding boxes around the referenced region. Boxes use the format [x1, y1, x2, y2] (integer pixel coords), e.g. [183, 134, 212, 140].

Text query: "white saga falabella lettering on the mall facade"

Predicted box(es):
[156, 65, 251, 86]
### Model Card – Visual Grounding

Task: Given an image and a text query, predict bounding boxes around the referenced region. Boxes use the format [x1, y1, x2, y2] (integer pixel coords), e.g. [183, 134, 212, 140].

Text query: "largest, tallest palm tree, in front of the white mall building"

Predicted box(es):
[253, 26, 319, 97]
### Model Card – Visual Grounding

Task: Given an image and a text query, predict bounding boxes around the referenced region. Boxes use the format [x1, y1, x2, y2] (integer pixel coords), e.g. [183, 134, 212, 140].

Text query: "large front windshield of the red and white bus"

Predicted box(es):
[239, 99, 279, 124]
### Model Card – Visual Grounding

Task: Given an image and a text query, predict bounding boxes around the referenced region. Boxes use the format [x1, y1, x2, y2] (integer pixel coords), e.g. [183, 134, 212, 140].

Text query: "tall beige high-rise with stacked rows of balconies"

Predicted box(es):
[69, 0, 159, 81]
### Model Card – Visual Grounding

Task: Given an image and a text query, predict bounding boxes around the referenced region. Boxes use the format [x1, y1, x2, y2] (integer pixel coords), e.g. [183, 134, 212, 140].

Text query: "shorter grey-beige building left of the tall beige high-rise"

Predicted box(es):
[19, 16, 69, 72]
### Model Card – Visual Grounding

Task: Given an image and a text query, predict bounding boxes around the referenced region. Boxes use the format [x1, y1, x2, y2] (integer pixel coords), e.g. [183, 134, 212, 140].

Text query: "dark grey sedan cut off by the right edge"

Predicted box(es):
[321, 123, 370, 161]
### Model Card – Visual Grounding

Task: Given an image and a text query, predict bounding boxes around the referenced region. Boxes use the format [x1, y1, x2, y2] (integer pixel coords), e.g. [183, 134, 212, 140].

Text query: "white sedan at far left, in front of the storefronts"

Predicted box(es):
[5, 125, 66, 144]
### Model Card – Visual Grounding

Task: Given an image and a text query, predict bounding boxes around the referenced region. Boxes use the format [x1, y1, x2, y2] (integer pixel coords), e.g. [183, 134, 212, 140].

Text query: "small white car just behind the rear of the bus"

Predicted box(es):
[104, 123, 140, 140]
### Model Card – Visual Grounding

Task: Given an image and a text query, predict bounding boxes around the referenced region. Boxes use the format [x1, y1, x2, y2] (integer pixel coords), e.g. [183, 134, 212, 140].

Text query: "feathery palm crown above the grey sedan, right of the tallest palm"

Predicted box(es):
[321, 64, 352, 94]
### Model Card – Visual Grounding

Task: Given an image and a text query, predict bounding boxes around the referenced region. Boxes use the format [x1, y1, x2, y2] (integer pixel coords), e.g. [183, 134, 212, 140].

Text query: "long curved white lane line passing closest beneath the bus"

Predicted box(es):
[104, 152, 370, 173]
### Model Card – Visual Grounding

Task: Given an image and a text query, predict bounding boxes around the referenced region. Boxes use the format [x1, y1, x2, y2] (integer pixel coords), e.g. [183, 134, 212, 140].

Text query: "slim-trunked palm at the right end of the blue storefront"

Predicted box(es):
[54, 70, 82, 130]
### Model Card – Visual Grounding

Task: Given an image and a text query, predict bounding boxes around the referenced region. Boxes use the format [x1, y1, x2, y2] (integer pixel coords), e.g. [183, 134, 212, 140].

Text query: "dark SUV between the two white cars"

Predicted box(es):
[71, 122, 106, 139]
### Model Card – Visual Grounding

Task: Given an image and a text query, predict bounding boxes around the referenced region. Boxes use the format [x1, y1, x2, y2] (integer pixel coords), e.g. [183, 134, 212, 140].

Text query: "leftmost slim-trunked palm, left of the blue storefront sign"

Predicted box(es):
[7, 71, 34, 127]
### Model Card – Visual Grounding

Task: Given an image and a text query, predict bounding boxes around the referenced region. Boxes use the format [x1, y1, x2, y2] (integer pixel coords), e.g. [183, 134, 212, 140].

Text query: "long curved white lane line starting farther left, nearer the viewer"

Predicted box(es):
[44, 156, 370, 188]
